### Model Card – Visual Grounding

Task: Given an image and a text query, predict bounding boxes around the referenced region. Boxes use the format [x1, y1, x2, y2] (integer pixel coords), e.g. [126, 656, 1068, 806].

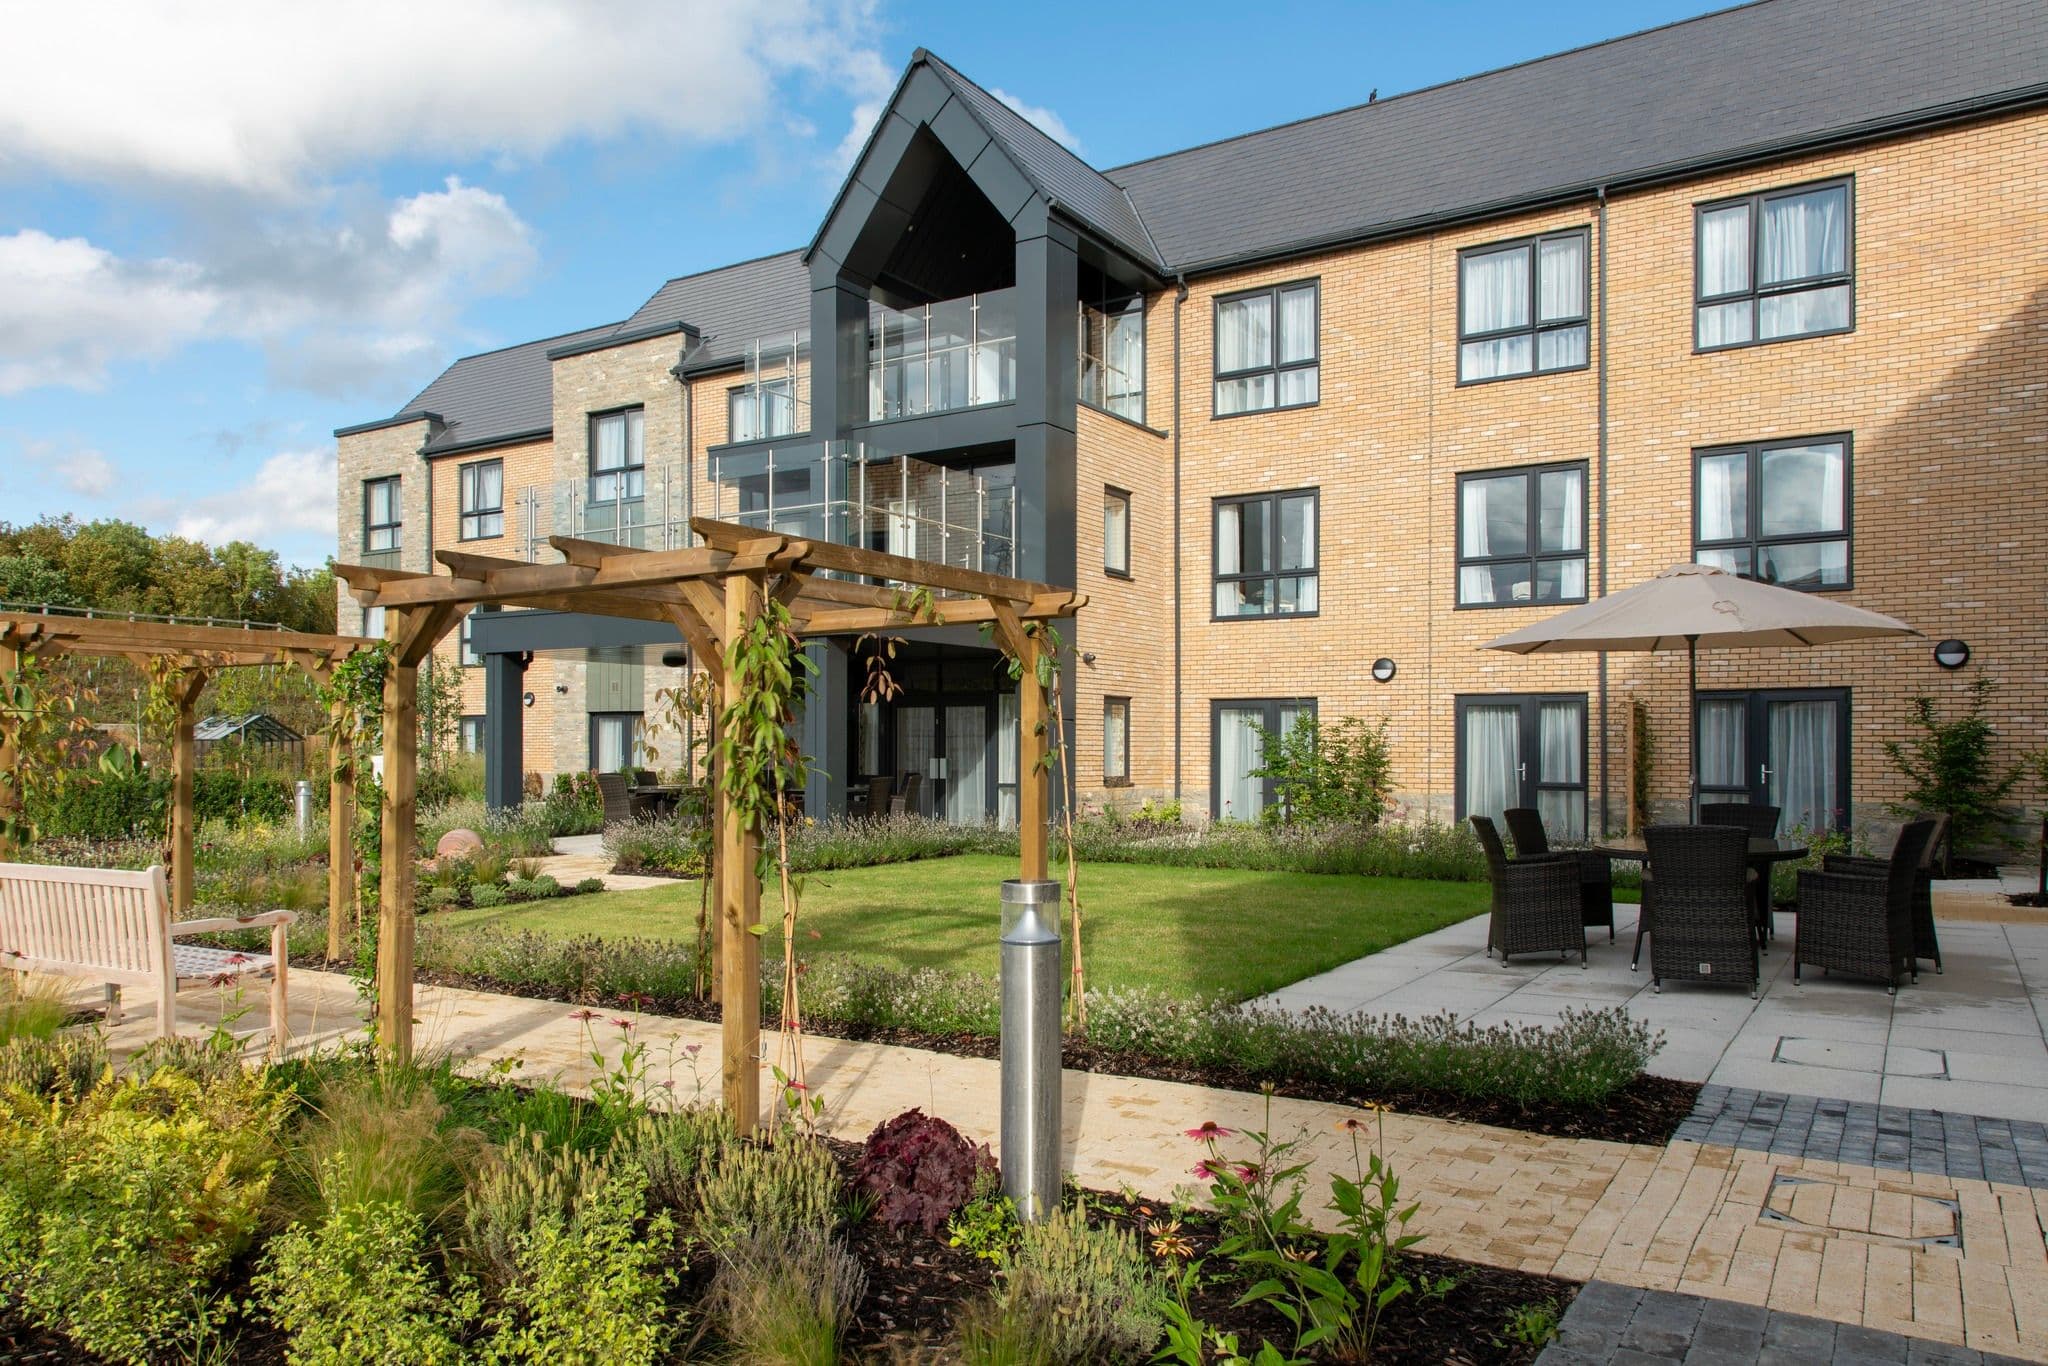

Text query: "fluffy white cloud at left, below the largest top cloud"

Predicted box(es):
[0, 176, 539, 395]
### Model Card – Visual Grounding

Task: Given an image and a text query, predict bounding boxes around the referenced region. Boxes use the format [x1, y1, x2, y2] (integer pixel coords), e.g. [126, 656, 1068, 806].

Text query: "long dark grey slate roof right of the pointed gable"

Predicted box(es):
[1106, 0, 2048, 272]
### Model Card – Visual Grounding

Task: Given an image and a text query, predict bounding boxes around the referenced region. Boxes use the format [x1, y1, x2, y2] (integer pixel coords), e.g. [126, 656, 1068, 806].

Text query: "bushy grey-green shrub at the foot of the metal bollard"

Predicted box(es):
[1006, 1208, 1165, 1362]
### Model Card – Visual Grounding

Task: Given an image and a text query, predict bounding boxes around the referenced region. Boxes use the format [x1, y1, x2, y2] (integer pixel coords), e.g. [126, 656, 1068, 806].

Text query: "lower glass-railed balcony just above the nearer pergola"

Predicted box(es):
[705, 440, 1016, 573]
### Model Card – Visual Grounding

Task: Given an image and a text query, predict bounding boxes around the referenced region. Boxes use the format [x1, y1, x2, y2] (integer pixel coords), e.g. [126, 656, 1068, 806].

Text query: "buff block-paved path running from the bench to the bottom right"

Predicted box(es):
[80, 971, 2048, 1360]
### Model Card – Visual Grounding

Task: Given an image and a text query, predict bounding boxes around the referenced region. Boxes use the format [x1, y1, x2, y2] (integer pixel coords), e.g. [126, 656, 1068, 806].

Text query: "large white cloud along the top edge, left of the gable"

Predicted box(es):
[0, 0, 881, 195]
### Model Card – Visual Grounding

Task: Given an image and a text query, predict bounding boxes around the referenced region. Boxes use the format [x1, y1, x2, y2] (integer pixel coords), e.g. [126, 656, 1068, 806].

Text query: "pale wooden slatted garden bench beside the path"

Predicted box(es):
[0, 862, 299, 1057]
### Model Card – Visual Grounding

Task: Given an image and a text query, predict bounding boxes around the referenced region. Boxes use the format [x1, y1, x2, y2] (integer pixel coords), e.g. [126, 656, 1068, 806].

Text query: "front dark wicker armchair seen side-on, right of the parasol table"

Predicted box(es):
[1792, 819, 1935, 993]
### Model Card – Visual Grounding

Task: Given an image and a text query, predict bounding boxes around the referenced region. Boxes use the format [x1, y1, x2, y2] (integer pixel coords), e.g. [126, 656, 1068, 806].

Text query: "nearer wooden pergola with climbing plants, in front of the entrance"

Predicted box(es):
[334, 518, 1085, 1130]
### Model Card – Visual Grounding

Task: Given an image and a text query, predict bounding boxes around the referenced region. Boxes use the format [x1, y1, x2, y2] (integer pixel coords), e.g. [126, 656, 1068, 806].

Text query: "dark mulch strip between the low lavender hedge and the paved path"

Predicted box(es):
[360, 958, 1700, 1145]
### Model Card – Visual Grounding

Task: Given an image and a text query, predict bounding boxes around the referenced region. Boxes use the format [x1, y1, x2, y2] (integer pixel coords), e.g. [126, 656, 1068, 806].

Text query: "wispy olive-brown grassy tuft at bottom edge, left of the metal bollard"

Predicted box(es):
[711, 1229, 866, 1366]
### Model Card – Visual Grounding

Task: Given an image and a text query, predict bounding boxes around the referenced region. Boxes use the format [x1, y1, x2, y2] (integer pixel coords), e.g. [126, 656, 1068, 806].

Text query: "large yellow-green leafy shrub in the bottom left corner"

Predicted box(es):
[0, 1067, 279, 1362]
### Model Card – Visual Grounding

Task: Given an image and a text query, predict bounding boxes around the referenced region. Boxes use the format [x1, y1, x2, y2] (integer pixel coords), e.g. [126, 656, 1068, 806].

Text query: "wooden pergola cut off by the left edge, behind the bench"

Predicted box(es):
[0, 612, 377, 958]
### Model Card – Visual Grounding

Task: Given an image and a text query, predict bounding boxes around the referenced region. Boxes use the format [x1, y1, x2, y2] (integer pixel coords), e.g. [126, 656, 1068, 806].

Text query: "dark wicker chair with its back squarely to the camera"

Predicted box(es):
[1636, 825, 1761, 997]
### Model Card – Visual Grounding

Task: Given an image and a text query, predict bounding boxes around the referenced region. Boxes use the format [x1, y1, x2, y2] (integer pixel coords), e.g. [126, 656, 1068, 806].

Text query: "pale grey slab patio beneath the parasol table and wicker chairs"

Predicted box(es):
[1264, 897, 2048, 1120]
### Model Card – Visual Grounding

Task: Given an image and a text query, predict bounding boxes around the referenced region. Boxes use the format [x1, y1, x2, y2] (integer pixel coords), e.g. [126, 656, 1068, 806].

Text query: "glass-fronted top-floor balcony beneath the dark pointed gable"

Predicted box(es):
[868, 289, 1018, 422]
